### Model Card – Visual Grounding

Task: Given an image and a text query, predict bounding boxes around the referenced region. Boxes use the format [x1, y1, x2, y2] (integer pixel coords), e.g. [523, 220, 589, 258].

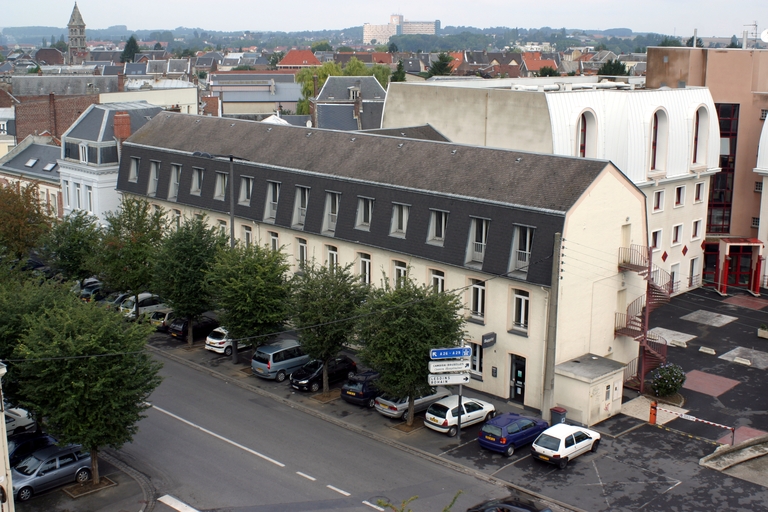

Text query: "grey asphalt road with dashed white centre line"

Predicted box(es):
[121, 360, 508, 512]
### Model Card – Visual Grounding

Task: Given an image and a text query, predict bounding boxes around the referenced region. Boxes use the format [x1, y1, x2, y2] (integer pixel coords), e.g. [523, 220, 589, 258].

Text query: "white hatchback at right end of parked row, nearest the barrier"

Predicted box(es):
[531, 423, 600, 469]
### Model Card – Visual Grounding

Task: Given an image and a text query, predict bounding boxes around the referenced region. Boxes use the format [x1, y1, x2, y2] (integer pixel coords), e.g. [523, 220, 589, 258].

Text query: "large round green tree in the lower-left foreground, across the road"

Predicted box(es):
[13, 296, 161, 483]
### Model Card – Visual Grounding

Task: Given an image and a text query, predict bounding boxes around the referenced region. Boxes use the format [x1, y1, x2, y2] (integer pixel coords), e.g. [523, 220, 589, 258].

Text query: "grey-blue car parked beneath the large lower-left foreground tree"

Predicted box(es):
[11, 445, 91, 501]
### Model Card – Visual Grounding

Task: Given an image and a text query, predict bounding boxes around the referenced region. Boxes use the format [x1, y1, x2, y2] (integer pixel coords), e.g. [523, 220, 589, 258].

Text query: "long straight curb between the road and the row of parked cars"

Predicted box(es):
[145, 345, 587, 512]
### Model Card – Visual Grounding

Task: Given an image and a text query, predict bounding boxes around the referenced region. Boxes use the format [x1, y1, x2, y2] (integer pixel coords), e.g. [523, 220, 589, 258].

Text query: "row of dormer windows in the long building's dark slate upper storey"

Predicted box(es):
[129, 158, 535, 272]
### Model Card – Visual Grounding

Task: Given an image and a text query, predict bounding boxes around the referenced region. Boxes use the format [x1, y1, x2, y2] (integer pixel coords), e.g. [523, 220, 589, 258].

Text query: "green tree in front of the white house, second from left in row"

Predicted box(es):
[42, 210, 101, 283]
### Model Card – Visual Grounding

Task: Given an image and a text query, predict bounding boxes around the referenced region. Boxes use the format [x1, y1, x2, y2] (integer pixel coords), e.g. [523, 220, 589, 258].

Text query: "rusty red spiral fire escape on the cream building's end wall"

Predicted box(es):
[614, 245, 675, 393]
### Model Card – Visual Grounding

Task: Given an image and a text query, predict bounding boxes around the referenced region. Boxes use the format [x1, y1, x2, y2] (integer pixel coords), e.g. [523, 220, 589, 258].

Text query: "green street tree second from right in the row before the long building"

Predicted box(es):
[292, 261, 367, 396]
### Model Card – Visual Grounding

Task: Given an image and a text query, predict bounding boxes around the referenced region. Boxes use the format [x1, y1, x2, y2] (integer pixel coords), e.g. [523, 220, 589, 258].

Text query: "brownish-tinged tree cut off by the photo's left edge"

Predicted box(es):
[0, 182, 52, 259]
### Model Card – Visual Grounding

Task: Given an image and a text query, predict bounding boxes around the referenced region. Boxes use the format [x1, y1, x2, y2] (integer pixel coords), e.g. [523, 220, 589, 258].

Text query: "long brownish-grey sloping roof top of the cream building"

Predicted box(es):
[125, 112, 609, 214]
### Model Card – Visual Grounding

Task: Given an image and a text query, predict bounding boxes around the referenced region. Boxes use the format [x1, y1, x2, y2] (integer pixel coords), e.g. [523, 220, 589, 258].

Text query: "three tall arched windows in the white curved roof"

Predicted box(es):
[577, 106, 709, 172]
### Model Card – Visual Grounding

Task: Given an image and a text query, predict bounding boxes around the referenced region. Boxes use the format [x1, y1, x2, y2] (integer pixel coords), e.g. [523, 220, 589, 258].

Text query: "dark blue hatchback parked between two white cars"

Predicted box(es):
[477, 412, 549, 457]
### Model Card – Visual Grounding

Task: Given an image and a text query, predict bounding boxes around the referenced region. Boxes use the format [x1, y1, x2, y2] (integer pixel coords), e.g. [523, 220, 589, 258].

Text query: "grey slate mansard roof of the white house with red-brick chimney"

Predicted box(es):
[62, 101, 163, 142]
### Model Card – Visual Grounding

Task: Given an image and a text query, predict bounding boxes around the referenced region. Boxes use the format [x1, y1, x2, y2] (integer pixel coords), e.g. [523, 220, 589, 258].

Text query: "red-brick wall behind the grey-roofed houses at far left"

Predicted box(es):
[16, 94, 99, 140]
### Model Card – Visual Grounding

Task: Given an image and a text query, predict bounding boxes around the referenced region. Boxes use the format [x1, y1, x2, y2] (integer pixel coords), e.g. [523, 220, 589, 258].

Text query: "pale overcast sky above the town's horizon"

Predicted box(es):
[0, 0, 768, 37]
